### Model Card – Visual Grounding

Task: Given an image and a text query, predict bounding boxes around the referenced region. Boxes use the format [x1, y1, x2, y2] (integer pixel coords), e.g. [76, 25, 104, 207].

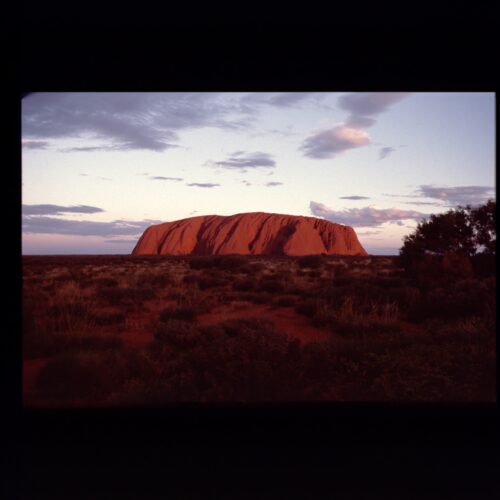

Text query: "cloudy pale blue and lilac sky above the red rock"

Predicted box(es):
[21, 92, 496, 255]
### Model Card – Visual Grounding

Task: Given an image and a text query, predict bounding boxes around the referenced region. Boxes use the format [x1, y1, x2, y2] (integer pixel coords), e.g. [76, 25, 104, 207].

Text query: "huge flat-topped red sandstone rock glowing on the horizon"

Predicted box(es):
[132, 212, 368, 255]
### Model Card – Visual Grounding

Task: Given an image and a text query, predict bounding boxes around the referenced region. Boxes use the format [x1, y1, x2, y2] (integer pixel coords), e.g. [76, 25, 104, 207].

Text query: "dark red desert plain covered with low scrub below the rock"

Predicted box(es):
[22, 255, 496, 407]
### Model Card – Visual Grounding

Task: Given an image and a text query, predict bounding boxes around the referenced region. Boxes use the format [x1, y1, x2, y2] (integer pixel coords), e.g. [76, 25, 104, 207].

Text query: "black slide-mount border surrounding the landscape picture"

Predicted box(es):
[3, 13, 499, 498]
